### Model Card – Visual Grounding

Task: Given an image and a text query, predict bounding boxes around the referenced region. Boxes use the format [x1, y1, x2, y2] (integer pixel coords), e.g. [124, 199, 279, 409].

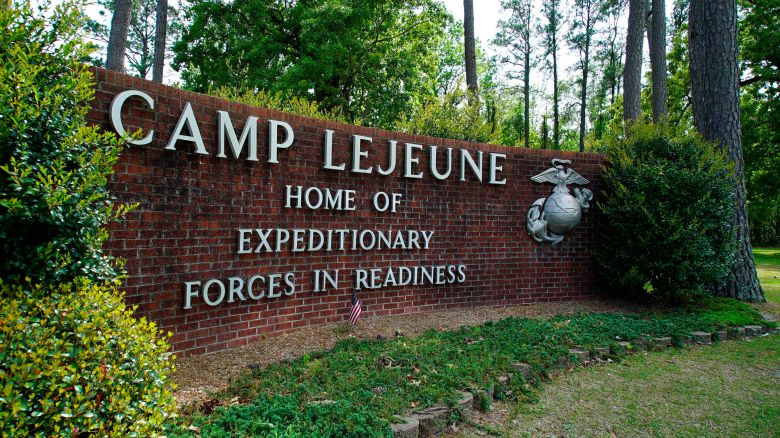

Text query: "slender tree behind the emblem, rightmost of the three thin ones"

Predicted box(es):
[569, 0, 602, 152]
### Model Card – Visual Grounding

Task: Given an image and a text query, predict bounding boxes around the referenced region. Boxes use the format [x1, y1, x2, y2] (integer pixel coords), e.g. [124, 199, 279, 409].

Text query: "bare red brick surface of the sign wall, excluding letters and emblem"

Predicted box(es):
[89, 69, 602, 355]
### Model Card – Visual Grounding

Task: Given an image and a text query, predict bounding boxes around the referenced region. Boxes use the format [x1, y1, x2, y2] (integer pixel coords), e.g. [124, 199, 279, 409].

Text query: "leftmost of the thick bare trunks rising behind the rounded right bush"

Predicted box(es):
[623, 0, 645, 124]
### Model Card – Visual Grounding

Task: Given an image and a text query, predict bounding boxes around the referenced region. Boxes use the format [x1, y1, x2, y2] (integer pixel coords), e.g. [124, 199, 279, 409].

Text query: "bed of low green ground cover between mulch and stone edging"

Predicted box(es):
[169, 299, 761, 437]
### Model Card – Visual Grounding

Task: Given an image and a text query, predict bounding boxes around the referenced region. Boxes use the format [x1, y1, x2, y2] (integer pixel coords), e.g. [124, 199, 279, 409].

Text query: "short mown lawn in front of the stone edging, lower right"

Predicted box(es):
[500, 336, 780, 437]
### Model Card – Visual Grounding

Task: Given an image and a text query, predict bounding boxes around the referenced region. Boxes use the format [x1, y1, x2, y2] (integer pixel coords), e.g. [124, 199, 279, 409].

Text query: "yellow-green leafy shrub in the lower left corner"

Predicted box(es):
[0, 280, 176, 436]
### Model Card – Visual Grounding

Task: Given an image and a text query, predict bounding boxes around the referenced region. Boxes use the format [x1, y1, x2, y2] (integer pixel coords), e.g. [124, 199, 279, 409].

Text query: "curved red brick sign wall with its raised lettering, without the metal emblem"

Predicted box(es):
[89, 69, 601, 355]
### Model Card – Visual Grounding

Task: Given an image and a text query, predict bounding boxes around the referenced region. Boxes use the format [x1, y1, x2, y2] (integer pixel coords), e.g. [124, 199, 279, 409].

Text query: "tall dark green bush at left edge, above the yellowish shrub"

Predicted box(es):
[0, 1, 133, 283]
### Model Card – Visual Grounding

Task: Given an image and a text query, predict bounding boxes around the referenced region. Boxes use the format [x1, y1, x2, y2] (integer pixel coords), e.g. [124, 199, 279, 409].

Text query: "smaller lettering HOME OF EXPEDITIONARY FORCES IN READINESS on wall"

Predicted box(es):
[184, 185, 466, 309]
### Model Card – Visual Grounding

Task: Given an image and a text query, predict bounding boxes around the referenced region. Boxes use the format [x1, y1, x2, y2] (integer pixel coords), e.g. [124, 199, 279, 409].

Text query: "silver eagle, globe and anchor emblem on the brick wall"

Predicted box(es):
[526, 158, 593, 245]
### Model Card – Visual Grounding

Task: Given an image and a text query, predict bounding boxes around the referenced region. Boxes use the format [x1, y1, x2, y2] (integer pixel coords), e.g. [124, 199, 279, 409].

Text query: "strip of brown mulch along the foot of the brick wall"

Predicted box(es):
[173, 300, 646, 406]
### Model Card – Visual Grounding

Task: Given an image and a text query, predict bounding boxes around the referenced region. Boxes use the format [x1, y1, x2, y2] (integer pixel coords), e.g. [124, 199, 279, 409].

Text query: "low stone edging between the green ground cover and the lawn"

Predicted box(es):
[390, 325, 780, 438]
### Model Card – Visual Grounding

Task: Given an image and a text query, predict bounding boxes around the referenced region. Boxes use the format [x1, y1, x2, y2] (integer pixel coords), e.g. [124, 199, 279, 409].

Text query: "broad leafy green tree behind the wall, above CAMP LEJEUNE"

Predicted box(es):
[173, 0, 451, 127]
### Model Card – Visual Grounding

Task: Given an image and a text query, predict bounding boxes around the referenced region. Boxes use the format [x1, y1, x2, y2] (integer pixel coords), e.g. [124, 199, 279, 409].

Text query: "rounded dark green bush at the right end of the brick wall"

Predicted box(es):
[597, 124, 736, 300]
